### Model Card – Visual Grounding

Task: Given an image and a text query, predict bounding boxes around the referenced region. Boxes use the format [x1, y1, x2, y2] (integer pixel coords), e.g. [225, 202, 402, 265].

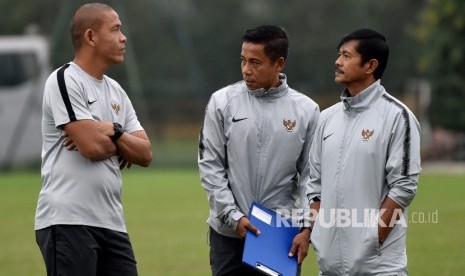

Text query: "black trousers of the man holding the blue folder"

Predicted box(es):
[209, 227, 264, 276]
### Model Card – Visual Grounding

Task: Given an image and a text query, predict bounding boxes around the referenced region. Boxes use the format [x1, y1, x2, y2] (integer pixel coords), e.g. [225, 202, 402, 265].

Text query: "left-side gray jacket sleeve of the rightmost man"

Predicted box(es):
[306, 116, 323, 201]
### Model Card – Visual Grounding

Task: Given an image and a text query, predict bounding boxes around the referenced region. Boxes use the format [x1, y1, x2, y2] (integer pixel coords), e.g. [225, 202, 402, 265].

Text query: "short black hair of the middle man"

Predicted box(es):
[242, 25, 289, 62]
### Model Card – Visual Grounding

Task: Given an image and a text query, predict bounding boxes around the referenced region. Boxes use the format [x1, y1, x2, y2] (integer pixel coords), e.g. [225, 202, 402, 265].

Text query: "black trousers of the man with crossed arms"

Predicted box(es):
[36, 225, 137, 276]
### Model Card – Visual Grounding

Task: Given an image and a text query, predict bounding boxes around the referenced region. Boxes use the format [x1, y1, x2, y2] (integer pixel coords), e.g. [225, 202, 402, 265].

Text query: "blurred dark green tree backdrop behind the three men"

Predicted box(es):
[0, 0, 465, 165]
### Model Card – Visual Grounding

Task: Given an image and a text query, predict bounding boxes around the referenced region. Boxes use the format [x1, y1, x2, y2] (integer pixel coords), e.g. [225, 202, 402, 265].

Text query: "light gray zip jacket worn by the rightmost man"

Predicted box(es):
[307, 80, 421, 275]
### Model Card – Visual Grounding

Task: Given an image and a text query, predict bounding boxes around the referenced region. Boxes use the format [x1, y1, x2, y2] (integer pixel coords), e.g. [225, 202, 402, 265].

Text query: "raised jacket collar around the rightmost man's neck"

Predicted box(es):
[341, 80, 384, 111]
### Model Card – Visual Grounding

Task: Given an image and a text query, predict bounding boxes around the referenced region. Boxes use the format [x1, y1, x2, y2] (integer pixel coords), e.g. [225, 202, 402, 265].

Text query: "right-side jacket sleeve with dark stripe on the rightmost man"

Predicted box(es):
[386, 108, 421, 208]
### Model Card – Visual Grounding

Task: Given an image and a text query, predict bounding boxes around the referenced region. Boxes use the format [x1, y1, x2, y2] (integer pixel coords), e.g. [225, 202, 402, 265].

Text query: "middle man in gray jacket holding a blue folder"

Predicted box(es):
[198, 25, 319, 276]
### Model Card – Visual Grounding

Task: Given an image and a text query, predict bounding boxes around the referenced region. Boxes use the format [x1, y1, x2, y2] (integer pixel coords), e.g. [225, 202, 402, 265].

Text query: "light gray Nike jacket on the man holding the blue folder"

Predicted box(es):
[198, 74, 319, 237]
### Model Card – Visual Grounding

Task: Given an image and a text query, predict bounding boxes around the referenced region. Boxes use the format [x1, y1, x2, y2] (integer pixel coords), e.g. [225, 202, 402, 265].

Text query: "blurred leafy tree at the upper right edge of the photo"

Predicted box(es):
[417, 0, 465, 131]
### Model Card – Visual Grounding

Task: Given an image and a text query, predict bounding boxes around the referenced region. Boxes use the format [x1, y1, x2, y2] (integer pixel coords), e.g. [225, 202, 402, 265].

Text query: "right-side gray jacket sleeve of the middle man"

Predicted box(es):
[297, 105, 320, 209]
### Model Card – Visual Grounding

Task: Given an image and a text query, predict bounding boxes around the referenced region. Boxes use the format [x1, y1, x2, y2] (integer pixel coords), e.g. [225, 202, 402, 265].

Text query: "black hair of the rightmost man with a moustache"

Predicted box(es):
[337, 29, 389, 80]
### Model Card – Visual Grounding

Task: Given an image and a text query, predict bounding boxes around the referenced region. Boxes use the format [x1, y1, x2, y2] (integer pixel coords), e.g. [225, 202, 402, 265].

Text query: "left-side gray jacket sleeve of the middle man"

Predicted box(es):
[198, 95, 244, 229]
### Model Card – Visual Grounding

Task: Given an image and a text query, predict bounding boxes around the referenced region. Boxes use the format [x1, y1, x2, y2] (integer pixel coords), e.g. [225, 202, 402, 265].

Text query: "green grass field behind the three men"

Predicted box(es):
[0, 169, 465, 276]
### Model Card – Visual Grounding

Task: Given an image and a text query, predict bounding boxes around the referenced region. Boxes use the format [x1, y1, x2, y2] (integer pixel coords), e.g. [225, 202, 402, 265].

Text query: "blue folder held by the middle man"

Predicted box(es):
[242, 202, 300, 276]
